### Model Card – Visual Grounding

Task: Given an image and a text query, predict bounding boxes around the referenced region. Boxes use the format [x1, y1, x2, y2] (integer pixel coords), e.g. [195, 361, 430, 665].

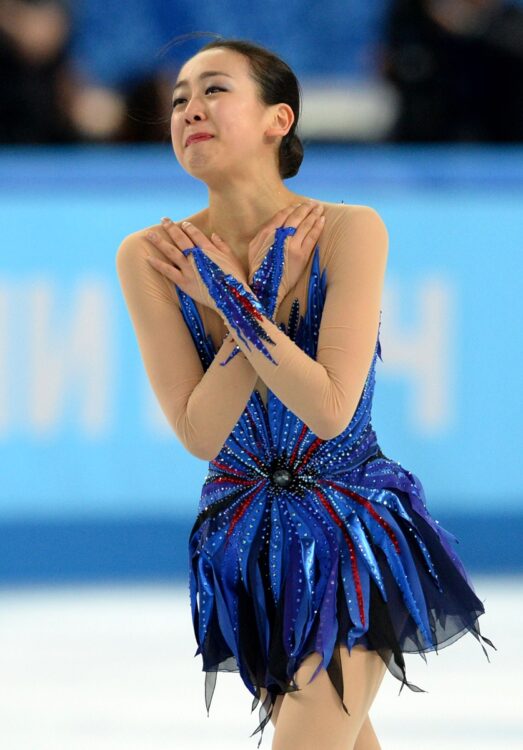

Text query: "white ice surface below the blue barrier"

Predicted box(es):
[0, 576, 523, 750]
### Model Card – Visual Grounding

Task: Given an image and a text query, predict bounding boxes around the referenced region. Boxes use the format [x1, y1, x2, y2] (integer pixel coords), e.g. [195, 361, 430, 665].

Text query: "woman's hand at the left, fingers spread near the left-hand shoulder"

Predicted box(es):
[146, 219, 252, 311]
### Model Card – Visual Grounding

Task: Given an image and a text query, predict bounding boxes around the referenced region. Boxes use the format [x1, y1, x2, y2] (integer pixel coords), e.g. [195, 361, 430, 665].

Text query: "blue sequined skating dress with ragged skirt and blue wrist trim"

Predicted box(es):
[176, 227, 496, 747]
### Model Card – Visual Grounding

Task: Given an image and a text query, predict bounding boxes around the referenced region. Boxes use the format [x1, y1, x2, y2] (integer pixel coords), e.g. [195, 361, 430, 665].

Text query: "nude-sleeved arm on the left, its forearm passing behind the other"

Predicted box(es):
[116, 229, 257, 461]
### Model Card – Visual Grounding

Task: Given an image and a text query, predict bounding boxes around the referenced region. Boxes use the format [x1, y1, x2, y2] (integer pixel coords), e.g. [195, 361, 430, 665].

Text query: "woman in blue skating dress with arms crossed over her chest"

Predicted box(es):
[117, 39, 493, 750]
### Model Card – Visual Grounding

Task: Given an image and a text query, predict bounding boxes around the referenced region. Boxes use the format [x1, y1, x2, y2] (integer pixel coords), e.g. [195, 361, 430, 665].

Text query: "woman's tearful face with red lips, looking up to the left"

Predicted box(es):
[171, 48, 275, 179]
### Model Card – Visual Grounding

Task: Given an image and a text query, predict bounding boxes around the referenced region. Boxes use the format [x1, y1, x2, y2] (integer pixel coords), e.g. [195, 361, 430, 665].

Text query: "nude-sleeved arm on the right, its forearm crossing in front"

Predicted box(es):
[201, 206, 388, 440]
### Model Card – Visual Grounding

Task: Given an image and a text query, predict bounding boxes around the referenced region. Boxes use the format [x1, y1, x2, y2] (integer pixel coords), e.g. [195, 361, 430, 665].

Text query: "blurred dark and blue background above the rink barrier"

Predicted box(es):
[4, 0, 523, 144]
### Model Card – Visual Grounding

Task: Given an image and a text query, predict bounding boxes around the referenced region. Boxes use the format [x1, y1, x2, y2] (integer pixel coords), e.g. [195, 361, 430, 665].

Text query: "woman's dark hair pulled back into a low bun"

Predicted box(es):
[160, 31, 303, 179]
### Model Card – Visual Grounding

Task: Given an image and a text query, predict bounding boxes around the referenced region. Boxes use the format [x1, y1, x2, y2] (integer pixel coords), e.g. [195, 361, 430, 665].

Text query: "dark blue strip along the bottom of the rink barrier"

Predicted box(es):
[0, 514, 523, 588]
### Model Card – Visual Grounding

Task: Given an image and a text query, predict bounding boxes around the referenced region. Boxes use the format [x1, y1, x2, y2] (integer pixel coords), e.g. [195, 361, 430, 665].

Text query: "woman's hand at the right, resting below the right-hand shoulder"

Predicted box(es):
[248, 201, 325, 305]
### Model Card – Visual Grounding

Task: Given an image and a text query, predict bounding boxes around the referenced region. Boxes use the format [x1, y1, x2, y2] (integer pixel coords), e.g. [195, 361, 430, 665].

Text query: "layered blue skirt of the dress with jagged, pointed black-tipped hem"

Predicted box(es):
[189, 440, 496, 747]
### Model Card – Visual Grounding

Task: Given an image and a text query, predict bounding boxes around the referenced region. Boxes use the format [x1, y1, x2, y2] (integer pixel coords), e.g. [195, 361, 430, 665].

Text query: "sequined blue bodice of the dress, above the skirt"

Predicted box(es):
[177, 246, 381, 507]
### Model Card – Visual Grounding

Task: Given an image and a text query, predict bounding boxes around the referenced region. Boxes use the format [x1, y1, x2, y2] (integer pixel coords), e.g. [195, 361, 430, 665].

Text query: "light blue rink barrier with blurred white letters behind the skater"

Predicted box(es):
[0, 145, 523, 584]
